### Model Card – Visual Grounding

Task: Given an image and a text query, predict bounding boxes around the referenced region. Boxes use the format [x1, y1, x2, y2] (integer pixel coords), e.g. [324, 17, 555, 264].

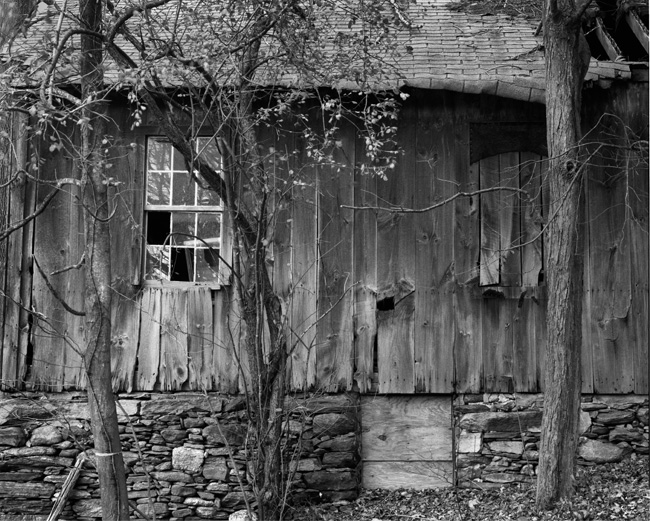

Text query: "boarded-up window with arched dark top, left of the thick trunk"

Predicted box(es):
[470, 123, 547, 287]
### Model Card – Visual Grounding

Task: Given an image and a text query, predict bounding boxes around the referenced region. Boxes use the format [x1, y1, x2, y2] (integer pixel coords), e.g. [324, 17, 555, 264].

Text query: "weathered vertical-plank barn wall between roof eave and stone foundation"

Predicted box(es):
[2, 83, 648, 394]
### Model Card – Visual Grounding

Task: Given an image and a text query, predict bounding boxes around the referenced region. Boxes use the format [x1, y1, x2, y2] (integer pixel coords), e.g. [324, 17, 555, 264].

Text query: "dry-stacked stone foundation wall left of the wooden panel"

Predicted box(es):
[0, 393, 360, 521]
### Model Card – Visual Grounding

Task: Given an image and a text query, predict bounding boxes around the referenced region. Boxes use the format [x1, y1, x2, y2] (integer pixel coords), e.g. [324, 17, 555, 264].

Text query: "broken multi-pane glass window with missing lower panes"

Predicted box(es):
[145, 137, 223, 286]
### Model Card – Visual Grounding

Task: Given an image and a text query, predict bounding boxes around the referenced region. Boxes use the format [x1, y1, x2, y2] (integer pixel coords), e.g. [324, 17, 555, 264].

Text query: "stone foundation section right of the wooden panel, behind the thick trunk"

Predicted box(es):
[454, 394, 648, 487]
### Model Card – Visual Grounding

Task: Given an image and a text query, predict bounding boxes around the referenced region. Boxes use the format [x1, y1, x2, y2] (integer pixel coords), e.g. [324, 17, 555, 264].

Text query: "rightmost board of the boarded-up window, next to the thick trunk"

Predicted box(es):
[520, 152, 544, 286]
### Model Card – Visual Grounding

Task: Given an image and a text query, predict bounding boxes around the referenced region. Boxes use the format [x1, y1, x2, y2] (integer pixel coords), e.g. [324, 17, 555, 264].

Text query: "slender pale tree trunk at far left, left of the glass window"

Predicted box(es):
[79, 0, 129, 521]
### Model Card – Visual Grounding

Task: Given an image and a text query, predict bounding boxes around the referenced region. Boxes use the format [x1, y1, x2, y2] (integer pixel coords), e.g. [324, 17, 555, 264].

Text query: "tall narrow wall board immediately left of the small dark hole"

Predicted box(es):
[352, 132, 377, 393]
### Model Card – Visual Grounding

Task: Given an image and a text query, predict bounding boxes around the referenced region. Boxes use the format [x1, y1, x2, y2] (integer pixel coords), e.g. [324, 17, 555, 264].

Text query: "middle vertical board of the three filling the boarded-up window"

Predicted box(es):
[499, 152, 521, 287]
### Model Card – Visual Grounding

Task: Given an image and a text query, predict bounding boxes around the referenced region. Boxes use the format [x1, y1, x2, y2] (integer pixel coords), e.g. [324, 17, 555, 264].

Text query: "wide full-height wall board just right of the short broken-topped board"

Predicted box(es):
[411, 95, 458, 392]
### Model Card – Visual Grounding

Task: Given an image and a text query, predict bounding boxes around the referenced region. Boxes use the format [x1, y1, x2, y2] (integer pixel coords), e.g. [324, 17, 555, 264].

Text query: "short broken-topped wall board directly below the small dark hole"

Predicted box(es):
[377, 285, 415, 394]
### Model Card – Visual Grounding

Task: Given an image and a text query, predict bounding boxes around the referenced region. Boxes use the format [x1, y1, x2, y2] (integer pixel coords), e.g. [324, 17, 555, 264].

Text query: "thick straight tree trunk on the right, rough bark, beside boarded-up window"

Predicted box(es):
[537, 0, 589, 508]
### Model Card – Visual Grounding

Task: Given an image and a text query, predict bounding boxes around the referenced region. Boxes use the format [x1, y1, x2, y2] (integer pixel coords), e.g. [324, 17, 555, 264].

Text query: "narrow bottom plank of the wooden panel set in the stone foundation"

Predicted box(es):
[361, 461, 454, 490]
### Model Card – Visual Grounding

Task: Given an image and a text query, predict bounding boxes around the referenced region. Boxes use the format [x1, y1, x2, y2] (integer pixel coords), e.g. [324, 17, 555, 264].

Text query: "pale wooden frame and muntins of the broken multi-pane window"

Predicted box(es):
[140, 133, 229, 290]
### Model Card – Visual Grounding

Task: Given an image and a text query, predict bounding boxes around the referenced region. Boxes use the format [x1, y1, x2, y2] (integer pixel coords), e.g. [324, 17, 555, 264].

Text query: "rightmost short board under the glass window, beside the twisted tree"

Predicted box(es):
[210, 288, 241, 394]
